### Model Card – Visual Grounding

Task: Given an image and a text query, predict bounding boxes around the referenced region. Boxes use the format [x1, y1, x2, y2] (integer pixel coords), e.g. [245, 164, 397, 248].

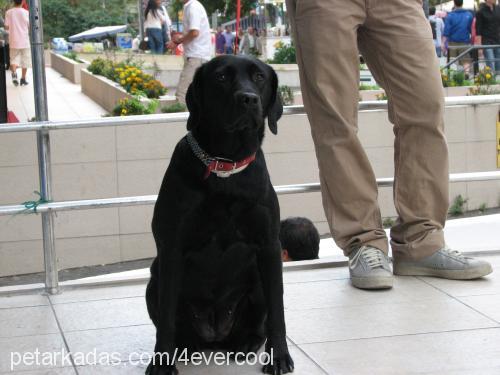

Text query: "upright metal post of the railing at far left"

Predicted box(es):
[30, 0, 59, 294]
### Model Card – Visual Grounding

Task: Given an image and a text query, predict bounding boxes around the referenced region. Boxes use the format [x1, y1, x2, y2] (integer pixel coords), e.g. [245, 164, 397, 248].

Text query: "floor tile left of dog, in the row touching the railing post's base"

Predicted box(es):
[50, 283, 146, 304]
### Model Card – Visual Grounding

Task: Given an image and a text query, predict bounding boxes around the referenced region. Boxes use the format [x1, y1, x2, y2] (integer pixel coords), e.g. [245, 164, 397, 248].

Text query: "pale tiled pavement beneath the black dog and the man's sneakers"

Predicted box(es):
[0, 256, 500, 375]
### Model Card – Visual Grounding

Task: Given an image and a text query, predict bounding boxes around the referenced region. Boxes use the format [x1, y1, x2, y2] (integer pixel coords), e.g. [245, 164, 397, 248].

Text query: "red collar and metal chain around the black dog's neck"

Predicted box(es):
[186, 132, 255, 179]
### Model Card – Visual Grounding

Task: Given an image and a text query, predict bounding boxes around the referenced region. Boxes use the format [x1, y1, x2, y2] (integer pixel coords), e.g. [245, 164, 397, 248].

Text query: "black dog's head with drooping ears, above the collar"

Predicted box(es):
[186, 56, 283, 139]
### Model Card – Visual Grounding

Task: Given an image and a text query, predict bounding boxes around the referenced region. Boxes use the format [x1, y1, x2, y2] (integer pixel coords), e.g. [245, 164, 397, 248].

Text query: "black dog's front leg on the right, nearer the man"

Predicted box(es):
[257, 241, 294, 375]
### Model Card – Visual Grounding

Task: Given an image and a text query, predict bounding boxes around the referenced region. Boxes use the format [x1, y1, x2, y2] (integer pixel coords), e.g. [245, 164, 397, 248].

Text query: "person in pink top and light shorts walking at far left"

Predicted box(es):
[5, 0, 31, 86]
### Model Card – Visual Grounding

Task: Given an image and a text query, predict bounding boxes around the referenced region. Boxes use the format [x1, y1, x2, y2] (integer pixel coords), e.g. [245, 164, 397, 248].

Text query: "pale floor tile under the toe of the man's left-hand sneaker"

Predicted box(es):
[285, 277, 448, 310]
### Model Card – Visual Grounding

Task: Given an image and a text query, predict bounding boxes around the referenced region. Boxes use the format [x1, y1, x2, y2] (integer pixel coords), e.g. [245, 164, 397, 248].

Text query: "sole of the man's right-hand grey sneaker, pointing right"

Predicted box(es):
[393, 264, 493, 280]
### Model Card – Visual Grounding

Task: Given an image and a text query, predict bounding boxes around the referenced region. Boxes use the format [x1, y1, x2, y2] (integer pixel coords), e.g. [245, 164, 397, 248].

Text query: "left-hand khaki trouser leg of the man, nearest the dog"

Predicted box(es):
[287, 0, 388, 255]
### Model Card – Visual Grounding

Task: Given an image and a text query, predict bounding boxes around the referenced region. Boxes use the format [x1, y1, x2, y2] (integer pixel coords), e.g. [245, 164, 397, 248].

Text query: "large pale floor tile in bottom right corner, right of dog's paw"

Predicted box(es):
[300, 328, 500, 375]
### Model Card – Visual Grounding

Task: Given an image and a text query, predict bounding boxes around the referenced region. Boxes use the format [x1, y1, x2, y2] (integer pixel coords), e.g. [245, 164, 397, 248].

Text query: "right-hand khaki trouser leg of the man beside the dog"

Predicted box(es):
[360, 0, 448, 259]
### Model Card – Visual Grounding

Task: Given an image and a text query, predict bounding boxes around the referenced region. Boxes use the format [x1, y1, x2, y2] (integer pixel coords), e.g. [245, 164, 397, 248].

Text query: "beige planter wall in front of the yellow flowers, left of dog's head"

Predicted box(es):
[81, 69, 175, 113]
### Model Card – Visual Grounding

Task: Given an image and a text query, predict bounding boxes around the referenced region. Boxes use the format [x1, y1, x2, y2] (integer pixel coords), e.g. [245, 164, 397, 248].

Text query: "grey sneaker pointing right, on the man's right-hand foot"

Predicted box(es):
[394, 247, 493, 280]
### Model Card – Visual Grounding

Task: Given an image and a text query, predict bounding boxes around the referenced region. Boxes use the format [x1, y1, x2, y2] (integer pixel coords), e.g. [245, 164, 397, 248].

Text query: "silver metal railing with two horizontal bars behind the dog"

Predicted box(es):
[0, 95, 500, 294]
